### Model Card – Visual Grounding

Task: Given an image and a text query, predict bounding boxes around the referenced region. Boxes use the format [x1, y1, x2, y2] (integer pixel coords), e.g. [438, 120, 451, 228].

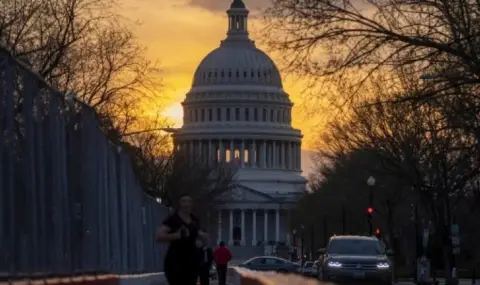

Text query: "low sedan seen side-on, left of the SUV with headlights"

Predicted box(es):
[238, 256, 302, 273]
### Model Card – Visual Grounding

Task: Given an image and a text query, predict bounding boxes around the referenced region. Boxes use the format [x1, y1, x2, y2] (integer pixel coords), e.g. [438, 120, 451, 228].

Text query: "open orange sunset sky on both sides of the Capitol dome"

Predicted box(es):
[123, 0, 318, 171]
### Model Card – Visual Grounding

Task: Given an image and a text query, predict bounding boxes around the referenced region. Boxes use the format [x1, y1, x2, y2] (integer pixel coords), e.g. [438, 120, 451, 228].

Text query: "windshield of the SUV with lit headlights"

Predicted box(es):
[327, 239, 384, 255]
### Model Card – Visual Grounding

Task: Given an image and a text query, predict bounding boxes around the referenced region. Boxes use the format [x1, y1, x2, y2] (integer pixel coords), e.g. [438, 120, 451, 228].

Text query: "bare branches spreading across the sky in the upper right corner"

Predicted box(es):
[263, 0, 480, 102]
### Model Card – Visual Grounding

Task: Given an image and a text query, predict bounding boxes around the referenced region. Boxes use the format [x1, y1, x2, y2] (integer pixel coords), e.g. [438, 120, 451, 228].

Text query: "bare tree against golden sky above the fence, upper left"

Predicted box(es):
[0, 0, 160, 134]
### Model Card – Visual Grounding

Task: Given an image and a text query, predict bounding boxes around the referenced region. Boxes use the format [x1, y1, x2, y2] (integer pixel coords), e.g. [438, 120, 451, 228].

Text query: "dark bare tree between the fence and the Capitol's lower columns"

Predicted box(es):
[126, 132, 237, 221]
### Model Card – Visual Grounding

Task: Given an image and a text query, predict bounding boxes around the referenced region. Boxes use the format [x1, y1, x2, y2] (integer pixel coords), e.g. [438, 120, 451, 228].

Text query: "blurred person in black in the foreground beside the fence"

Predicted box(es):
[156, 194, 207, 285]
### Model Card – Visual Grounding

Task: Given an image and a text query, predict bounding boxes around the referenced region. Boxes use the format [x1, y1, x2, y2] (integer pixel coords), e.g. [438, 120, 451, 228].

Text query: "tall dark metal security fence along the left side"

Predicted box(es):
[0, 48, 168, 278]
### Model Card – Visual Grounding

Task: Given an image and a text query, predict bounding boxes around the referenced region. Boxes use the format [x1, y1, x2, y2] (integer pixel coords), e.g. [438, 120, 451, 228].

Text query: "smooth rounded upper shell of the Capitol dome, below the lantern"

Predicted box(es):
[192, 45, 282, 88]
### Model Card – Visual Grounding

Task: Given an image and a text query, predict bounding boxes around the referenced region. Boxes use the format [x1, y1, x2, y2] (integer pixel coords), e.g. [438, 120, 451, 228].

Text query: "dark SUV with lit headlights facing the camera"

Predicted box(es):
[318, 236, 393, 285]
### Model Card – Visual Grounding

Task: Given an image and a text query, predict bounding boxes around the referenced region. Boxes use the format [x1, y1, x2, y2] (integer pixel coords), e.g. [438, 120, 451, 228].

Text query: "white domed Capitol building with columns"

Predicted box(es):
[169, 0, 306, 258]
